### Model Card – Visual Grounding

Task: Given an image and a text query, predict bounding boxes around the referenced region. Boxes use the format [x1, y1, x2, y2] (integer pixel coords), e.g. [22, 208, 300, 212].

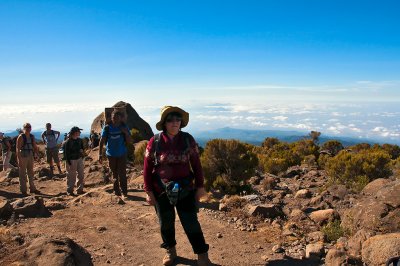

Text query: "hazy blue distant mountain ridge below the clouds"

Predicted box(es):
[193, 127, 388, 147]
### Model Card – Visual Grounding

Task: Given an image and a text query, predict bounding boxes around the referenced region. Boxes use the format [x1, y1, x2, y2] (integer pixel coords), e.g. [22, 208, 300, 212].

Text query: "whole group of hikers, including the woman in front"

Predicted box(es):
[0, 106, 212, 265]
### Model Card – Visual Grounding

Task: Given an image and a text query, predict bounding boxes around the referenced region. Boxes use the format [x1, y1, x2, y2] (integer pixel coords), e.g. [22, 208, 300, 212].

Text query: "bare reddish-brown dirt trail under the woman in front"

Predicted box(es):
[0, 175, 290, 265]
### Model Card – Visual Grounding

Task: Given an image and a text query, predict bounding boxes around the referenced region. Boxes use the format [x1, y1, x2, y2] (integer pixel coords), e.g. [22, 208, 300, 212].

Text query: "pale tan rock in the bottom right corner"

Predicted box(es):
[362, 233, 400, 265]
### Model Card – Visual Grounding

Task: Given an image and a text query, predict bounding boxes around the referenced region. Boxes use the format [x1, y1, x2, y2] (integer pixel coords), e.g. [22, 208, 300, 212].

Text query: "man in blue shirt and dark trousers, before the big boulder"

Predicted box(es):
[99, 111, 131, 198]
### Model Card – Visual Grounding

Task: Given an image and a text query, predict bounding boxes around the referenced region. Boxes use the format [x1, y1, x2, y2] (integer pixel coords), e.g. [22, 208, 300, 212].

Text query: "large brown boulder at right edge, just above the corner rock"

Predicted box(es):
[341, 179, 400, 233]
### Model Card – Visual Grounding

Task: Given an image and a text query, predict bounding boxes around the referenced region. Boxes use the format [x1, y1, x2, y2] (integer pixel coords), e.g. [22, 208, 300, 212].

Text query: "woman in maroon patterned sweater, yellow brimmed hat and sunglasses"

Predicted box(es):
[143, 106, 212, 265]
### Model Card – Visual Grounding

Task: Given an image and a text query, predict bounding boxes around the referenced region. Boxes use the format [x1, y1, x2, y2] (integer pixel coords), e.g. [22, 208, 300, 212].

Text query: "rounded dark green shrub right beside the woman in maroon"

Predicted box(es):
[201, 139, 258, 193]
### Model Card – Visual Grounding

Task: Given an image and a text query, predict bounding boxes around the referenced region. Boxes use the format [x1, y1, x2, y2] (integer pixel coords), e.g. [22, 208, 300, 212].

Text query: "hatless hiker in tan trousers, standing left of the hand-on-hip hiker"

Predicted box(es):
[16, 123, 40, 196]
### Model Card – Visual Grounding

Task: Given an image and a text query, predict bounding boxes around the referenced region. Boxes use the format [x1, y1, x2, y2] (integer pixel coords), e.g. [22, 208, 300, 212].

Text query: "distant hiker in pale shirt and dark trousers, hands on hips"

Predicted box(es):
[42, 123, 61, 175]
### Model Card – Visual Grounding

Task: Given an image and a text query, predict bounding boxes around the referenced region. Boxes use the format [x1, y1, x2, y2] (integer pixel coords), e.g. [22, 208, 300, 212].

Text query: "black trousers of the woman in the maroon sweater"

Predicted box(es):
[155, 191, 208, 254]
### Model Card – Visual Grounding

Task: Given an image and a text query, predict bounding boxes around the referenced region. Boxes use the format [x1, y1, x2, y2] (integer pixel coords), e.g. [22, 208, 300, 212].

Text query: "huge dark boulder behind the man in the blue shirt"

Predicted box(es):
[91, 101, 154, 140]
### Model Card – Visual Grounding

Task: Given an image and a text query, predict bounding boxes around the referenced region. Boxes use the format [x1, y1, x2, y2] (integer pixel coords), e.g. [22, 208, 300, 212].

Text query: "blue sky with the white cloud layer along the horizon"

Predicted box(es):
[0, 0, 400, 142]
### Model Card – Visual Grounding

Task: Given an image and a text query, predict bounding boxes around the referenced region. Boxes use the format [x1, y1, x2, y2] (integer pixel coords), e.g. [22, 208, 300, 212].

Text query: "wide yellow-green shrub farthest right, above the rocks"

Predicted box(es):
[326, 149, 392, 191]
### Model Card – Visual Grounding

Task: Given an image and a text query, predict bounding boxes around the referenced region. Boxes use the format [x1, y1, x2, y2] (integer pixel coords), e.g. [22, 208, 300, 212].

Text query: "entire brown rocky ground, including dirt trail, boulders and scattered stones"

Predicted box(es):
[0, 147, 400, 265]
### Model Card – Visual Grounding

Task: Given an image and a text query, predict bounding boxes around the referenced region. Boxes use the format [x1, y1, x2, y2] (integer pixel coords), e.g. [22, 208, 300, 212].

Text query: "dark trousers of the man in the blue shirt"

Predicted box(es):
[108, 155, 128, 194]
